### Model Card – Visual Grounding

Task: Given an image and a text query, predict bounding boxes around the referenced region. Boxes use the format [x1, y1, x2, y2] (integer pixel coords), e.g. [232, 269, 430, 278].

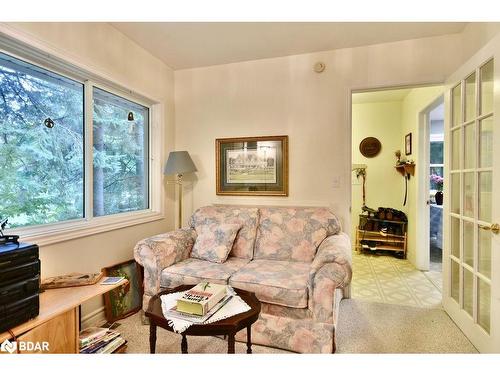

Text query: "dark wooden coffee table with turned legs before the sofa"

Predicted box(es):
[146, 285, 260, 354]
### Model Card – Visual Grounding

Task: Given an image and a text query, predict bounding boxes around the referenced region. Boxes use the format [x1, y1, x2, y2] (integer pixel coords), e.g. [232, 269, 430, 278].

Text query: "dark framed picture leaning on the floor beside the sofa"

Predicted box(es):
[102, 259, 143, 323]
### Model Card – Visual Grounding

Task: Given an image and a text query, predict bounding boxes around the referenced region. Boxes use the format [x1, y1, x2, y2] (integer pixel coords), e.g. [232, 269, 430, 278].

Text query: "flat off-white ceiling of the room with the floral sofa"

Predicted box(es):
[111, 22, 466, 69]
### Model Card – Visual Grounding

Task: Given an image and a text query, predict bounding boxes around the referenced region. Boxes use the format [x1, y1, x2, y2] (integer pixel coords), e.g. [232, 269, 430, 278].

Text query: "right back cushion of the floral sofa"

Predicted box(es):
[254, 207, 340, 262]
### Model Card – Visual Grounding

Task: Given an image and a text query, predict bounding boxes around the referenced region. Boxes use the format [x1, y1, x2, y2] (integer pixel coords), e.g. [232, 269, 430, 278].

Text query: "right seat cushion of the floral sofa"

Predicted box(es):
[229, 259, 310, 308]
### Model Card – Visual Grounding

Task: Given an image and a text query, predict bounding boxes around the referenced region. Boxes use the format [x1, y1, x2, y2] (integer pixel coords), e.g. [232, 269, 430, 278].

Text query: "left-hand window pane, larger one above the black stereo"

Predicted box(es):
[0, 53, 84, 227]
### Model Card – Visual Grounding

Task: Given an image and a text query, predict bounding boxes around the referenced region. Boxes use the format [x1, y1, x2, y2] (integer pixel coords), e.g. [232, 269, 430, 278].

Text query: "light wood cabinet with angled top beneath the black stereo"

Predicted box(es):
[0, 280, 128, 353]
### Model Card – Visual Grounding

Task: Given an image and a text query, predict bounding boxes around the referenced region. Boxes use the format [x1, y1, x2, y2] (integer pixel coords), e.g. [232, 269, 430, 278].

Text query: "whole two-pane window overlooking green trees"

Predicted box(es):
[0, 52, 151, 232]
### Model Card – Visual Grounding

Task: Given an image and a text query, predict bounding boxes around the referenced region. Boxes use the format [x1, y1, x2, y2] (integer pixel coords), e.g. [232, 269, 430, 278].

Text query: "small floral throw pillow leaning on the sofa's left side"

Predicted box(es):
[191, 224, 241, 263]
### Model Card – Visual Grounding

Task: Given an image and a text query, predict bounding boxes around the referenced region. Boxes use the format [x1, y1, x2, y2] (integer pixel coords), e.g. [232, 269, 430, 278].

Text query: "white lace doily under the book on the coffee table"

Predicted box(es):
[160, 286, 250, 333]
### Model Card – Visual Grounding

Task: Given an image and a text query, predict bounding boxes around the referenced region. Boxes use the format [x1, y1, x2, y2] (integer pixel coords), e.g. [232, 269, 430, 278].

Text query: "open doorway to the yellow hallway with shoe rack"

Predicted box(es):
[351, 86, 443, 308]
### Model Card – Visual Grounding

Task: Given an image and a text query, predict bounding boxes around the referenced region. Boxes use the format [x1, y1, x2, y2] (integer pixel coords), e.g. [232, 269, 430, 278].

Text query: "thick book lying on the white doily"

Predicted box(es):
[177, 282, 227, 316]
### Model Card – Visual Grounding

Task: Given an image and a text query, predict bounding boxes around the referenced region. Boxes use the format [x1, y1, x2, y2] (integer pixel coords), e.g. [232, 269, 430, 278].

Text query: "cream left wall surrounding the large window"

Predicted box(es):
[0, 23, 174, 324]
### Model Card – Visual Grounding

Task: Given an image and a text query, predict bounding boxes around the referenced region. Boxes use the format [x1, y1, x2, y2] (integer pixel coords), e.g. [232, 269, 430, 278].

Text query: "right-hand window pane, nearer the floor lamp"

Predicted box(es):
[93, 88, 149, 216]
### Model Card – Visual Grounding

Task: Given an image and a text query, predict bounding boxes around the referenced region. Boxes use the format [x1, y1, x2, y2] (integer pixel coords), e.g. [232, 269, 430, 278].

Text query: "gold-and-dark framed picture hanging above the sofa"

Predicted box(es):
[215, 135, 288, 197]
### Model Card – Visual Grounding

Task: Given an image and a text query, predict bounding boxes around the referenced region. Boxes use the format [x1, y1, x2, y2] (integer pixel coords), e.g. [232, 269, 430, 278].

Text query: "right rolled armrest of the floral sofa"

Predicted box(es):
[309, 233, 352, 324]
